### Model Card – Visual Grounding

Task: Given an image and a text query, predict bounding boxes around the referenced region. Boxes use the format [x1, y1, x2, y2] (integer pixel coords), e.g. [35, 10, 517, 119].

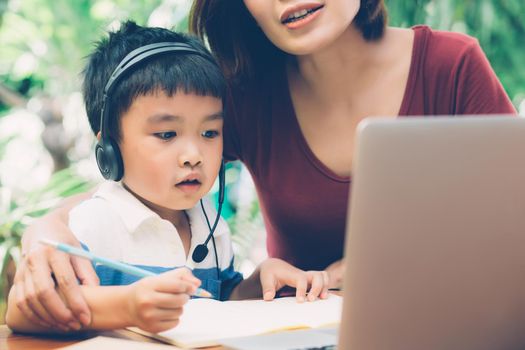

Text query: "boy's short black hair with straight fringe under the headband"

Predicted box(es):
[82, 21, 226, 142]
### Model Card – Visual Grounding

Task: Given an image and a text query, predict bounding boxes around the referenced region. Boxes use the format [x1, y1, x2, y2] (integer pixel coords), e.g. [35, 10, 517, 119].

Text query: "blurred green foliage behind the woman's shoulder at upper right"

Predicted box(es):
[386, 0, 525, 105]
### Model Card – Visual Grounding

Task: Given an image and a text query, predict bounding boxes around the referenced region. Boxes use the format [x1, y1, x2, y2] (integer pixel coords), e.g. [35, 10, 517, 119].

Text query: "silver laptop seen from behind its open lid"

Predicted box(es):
[223, 116, 525, 350]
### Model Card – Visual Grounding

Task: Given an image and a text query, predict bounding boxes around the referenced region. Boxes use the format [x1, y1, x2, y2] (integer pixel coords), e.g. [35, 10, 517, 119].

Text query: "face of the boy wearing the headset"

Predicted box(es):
[120, 91, 223, 210]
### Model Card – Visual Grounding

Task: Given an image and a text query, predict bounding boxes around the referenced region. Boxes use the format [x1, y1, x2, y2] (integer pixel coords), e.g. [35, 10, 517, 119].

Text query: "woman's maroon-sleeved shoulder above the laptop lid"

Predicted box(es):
[407, 26, 514, 114]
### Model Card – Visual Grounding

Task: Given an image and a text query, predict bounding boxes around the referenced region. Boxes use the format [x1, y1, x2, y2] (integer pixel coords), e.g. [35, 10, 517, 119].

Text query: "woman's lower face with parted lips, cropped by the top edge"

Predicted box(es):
[244, 0, 360, 55]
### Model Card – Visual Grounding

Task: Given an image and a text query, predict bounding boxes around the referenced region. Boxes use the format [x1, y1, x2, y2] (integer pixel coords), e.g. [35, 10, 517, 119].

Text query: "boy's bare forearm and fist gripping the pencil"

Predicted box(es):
[6, 269, 200, 333]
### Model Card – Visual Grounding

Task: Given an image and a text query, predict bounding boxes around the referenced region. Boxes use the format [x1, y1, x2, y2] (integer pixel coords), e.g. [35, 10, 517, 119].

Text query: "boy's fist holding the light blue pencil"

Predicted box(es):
[129, 268, 201, 333]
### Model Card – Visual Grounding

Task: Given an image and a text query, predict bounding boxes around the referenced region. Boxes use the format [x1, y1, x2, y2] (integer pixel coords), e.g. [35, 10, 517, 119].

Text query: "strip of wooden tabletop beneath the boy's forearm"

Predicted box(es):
[0, 325, 221, 350]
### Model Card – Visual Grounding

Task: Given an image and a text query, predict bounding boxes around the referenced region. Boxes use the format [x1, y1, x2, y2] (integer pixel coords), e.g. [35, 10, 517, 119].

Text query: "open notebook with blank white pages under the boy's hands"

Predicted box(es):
[130, 295, 342, 348]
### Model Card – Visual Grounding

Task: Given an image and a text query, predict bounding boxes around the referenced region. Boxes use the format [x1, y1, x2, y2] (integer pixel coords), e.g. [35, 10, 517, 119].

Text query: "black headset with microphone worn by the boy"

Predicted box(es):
[95, 42, 225, 274]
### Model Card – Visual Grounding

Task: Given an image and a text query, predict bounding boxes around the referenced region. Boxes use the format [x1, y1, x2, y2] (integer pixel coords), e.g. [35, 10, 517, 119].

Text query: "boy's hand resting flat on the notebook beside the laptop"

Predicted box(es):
[259, 258, 328, 302]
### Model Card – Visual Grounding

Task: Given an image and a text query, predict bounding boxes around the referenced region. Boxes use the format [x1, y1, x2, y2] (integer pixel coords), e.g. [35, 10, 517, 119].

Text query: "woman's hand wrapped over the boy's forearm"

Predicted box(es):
[14, 192, 98, 326]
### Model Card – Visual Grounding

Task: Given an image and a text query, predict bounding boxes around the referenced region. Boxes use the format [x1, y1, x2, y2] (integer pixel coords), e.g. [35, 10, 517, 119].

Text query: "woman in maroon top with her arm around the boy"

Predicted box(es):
[15, 0, 516, 330]
